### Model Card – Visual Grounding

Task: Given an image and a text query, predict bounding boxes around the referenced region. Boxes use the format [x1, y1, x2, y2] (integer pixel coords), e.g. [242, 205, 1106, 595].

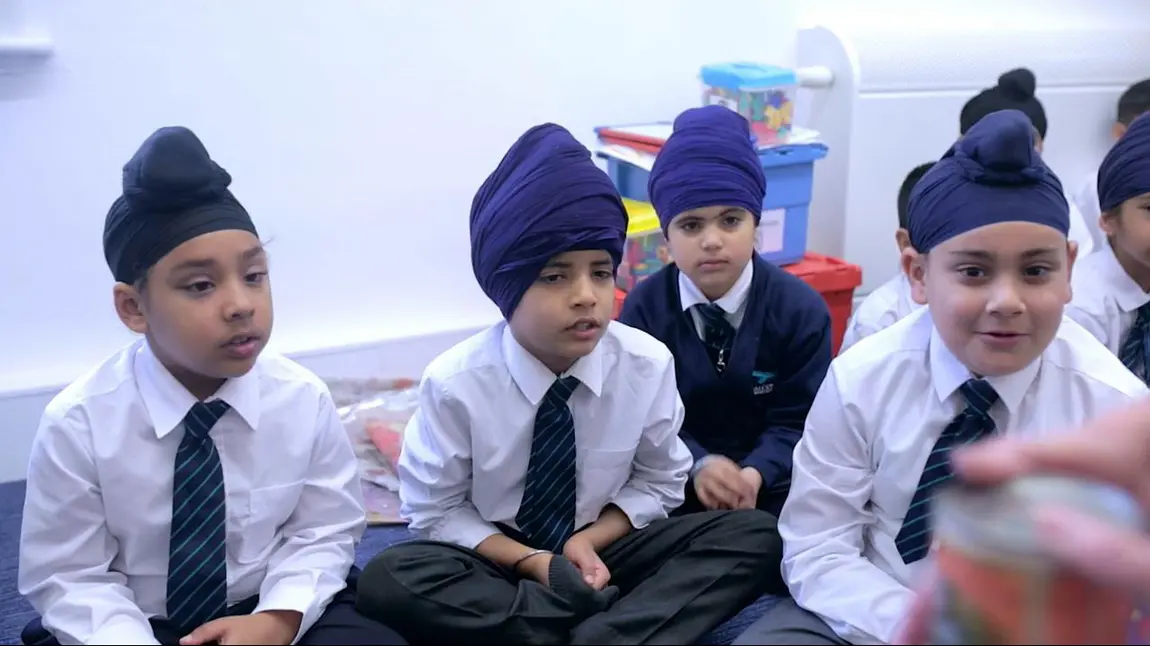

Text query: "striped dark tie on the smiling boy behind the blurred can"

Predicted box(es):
[895, 379, 998, 564]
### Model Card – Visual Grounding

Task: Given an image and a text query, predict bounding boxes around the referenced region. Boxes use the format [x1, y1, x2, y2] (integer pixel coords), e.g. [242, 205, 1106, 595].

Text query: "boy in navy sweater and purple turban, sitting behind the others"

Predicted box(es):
[620, 106, 830, 515]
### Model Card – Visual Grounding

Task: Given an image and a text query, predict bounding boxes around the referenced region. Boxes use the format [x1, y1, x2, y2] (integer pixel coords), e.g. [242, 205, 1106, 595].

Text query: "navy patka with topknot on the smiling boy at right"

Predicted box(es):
[909, 110, 1071, 253]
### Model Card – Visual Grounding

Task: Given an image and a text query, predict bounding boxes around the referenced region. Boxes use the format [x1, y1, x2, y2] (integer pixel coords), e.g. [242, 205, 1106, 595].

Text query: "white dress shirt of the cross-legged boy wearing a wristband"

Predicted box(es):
[399, 322, 691, 549]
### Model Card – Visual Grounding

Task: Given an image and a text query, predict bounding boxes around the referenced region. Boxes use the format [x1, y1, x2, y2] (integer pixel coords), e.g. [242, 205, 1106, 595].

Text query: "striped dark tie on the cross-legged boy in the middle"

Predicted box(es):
[515, 377, 578, 553]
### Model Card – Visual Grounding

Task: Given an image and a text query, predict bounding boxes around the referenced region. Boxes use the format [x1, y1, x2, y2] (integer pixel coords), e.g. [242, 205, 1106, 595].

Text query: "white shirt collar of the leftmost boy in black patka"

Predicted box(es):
[136, 341, 260, 438]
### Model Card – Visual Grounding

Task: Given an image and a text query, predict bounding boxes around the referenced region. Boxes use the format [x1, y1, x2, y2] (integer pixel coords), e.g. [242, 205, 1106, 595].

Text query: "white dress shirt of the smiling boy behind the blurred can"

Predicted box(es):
[779, 308, 1148, 644]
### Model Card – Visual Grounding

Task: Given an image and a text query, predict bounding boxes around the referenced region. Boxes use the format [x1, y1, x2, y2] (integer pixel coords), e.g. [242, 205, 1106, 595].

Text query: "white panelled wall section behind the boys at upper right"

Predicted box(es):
[796, 0, 1150, 291]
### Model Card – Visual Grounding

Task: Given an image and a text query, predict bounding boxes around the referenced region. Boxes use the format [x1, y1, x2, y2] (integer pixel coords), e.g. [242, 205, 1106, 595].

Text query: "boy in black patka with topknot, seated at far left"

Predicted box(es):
[18, 128, 404, 645]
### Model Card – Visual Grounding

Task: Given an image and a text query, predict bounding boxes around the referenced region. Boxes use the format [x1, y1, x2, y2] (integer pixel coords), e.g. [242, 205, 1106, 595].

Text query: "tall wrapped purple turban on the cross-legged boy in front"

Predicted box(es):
[472, 123, 627, 318]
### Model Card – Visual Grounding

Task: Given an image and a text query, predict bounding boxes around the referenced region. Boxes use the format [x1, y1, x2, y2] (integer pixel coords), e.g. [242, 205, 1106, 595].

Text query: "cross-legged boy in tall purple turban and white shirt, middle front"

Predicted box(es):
[359, 124, 781, 644]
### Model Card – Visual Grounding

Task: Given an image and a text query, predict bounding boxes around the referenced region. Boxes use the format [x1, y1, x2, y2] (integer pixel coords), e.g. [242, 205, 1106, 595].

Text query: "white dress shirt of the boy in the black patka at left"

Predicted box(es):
[18, 341, 366, 644]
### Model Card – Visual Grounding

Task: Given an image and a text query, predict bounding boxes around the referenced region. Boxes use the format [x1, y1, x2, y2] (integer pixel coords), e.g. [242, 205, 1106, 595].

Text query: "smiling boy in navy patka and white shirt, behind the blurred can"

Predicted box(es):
[736, 110, 1148, 644]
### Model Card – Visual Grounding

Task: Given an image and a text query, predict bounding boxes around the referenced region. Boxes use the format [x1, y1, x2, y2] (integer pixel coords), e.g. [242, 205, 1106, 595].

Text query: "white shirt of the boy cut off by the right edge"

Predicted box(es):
[1066, 244, 1150, 355]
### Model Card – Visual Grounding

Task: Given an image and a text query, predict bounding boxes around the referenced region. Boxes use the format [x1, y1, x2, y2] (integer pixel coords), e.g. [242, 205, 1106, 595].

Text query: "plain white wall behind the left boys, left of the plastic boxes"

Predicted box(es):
[0, 0, 798, 480]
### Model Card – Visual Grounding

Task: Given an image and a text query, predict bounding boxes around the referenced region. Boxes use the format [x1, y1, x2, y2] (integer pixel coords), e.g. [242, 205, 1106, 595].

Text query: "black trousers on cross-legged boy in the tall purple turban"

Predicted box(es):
[358, 509, 784, 644]
